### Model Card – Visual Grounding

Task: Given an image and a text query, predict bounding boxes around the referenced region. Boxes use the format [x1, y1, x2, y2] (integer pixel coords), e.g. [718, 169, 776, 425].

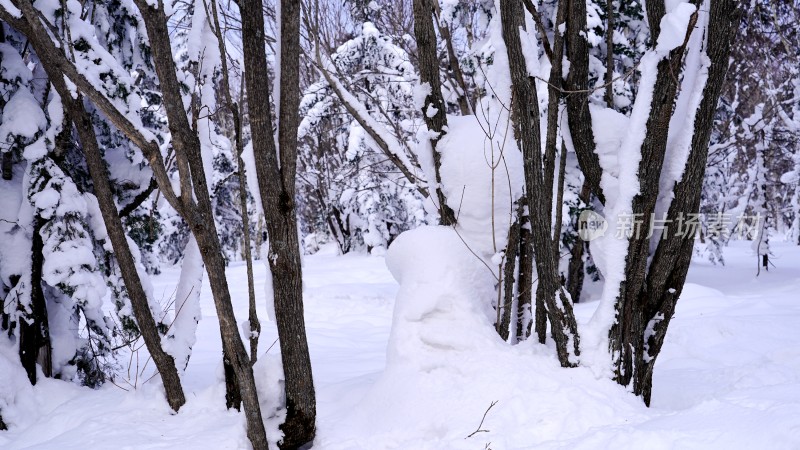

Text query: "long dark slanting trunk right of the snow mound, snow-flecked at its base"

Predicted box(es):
[500, 0, 580, 367]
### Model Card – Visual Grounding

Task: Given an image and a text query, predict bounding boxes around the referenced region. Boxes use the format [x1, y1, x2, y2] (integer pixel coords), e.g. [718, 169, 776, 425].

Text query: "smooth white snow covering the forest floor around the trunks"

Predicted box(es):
[0, 242, 800, 450]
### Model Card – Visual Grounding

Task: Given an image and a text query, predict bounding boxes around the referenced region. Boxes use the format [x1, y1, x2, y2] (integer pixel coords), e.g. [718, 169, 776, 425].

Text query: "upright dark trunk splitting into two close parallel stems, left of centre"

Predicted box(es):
[240, 0, 316, 448]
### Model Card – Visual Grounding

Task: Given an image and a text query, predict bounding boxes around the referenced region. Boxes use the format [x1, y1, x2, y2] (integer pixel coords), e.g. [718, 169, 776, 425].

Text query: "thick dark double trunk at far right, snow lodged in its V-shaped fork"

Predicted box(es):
[610, 0, 741, 405]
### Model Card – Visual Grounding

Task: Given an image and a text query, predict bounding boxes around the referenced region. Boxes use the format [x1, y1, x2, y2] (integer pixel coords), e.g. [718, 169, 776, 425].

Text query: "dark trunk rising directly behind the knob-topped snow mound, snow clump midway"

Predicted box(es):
[414, 0, 456, 225]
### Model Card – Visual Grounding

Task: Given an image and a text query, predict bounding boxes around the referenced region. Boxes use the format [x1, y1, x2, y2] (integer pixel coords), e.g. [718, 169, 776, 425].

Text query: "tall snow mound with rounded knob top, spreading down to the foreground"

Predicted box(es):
[315, 227, 646, 450]
